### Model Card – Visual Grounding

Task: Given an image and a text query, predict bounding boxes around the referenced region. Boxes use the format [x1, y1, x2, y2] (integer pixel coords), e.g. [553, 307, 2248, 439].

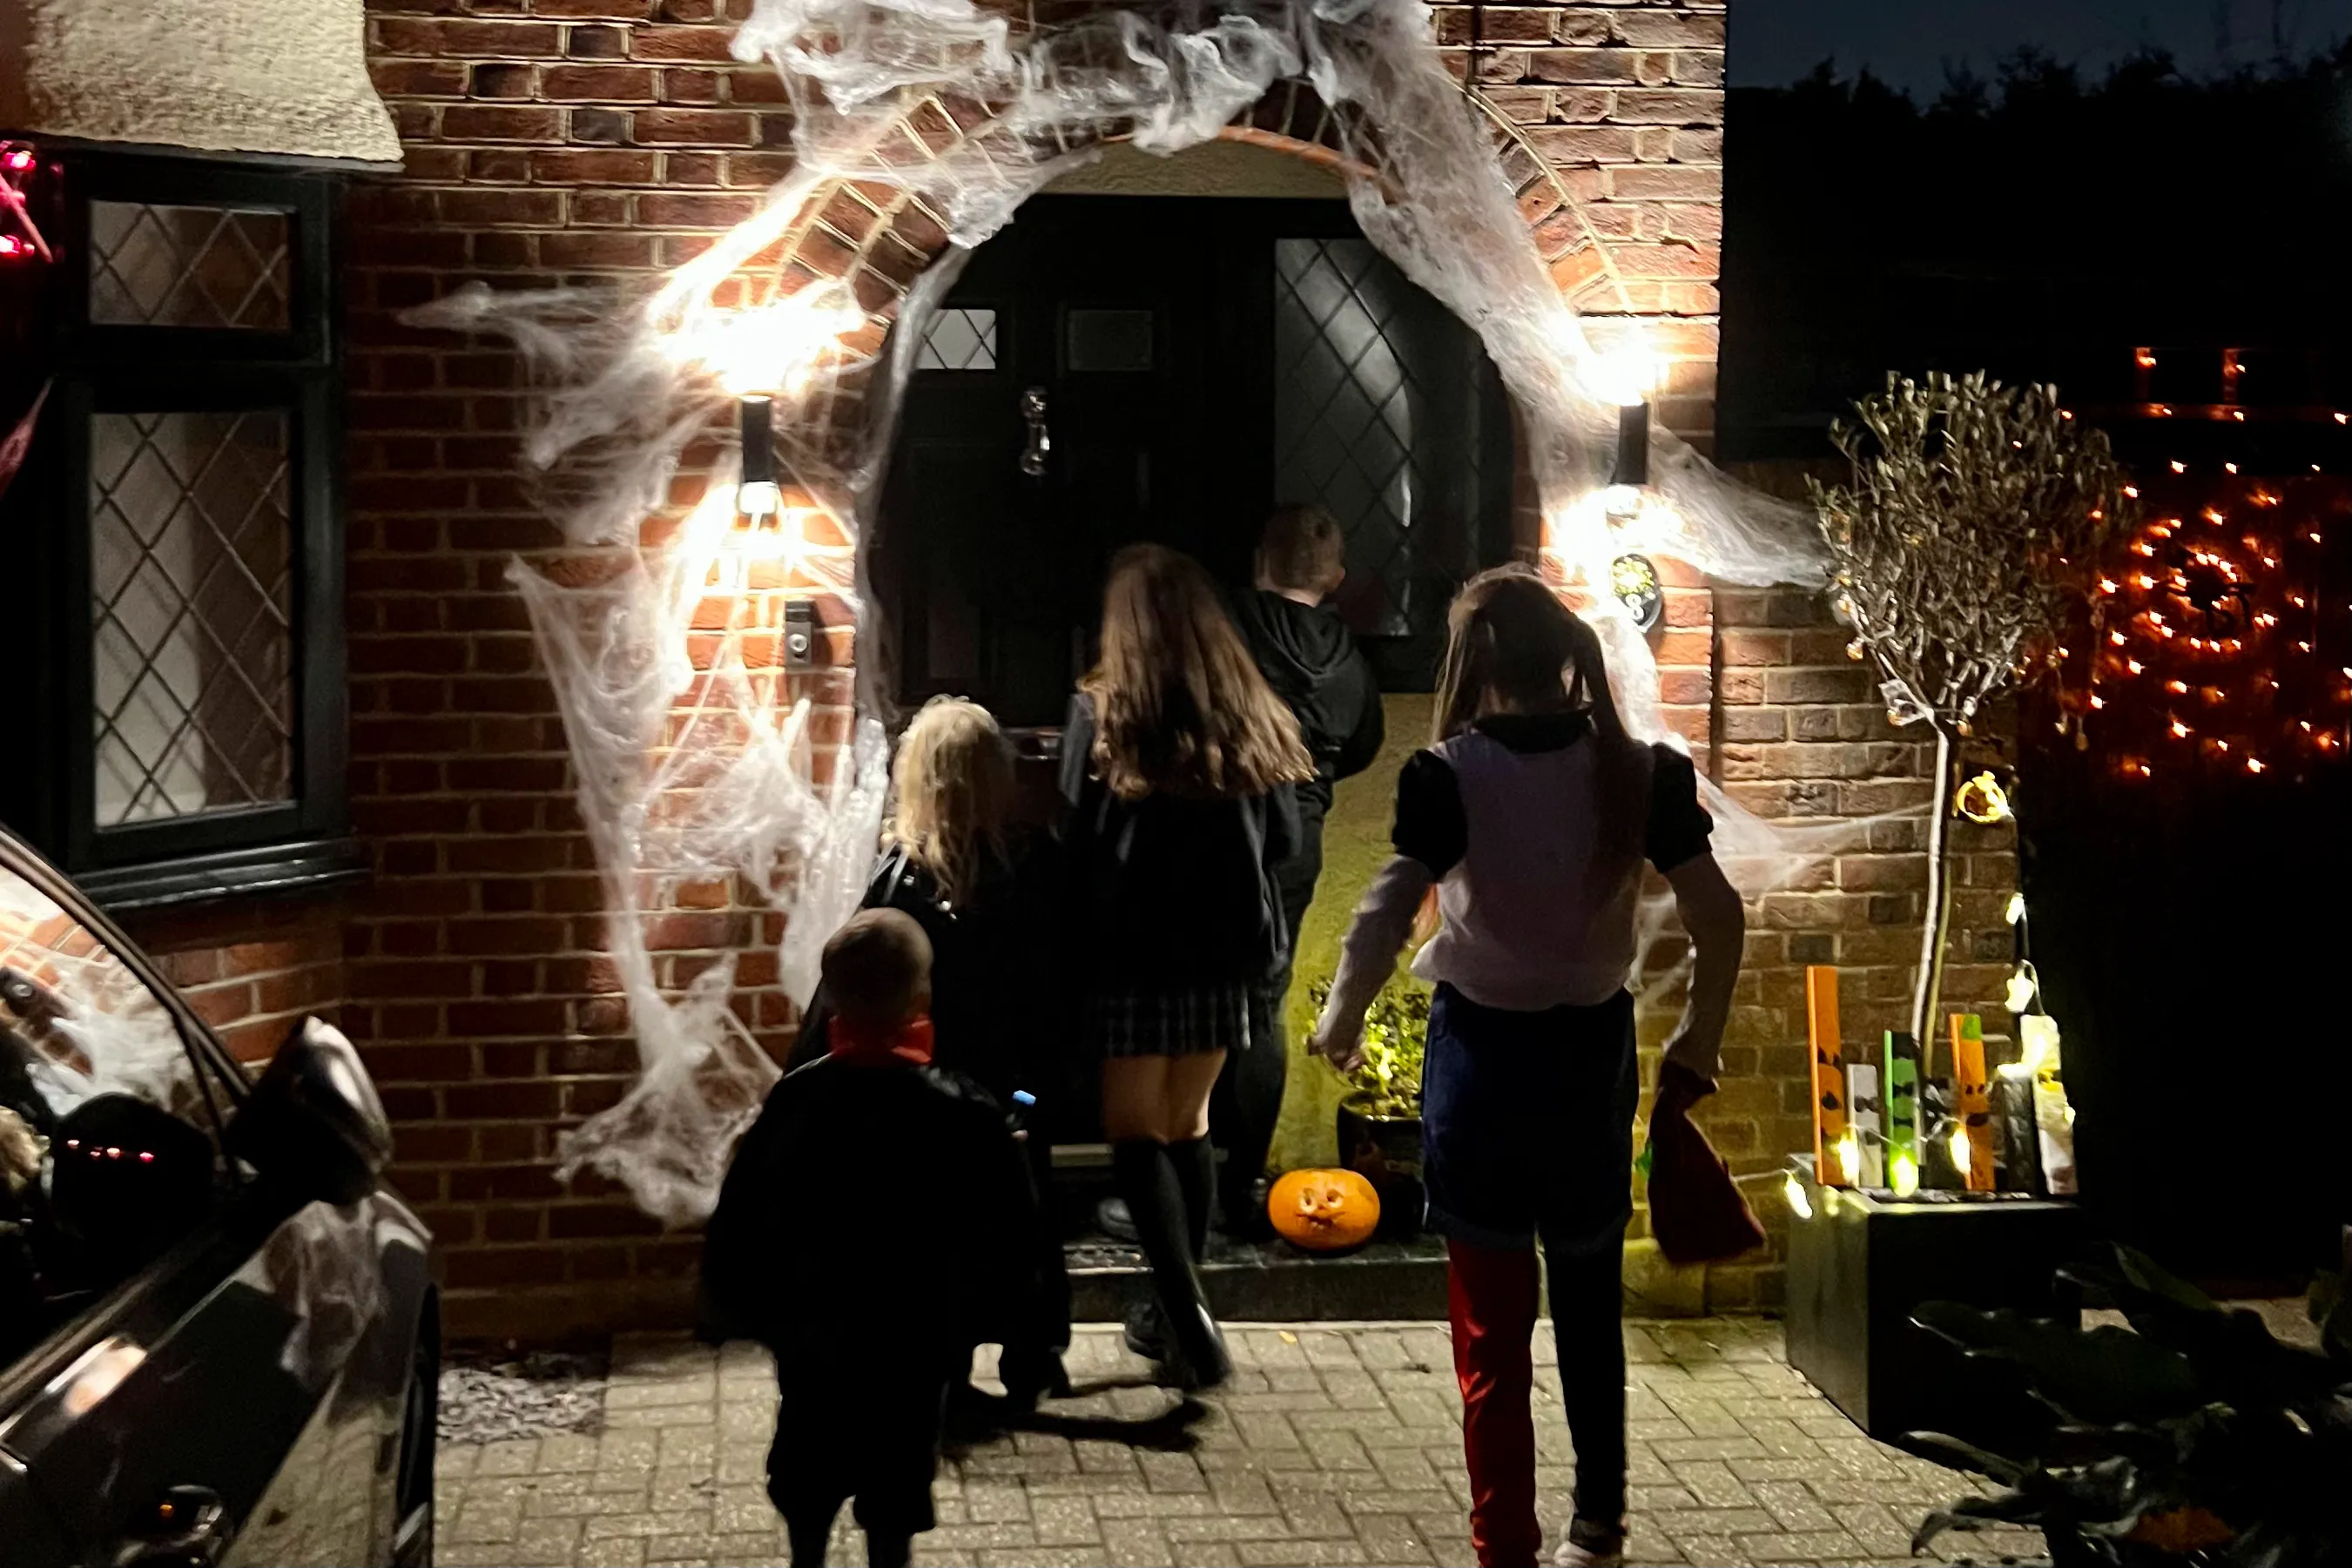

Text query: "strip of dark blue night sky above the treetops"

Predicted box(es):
[1731, 0, 2352, 97]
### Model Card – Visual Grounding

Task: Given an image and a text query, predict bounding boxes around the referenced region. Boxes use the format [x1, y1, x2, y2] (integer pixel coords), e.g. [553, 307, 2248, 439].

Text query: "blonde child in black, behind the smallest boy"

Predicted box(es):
[788, 696, 1073, 1410]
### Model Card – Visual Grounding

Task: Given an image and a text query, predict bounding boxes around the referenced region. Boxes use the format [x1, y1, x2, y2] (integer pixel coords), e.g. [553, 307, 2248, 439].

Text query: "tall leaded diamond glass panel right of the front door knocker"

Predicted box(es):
[1275, 239, 1428, 637]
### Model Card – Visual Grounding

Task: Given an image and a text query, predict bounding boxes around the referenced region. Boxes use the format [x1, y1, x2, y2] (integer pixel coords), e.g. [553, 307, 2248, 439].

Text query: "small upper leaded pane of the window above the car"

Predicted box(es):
[90, 202, 292, 332]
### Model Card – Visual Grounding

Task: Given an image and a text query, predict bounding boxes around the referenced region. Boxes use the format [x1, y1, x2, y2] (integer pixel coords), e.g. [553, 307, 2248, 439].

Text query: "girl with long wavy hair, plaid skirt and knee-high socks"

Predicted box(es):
[1063, 545, 1315, 1387]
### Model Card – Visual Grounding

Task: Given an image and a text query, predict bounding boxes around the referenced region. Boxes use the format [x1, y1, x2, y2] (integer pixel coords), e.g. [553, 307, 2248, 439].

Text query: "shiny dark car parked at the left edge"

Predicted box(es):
[0, 832, 440, 1568]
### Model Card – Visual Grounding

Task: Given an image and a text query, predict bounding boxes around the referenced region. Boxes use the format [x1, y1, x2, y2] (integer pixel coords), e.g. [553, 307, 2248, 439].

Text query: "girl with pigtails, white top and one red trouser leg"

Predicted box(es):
[1315, 567, 1745, 1568]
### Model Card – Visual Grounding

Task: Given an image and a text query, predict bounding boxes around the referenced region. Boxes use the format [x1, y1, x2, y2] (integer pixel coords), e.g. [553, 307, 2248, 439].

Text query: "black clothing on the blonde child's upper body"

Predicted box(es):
[788, 832, 1070, 1102]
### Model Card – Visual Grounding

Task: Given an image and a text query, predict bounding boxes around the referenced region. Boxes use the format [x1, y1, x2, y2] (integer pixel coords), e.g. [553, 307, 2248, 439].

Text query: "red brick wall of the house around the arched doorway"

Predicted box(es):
[336, 0, 2006, 1336]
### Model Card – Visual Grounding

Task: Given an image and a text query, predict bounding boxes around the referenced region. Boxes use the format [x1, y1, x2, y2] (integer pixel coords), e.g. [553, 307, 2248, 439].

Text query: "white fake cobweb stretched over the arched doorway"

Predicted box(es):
[412, 0, 1870, 1222]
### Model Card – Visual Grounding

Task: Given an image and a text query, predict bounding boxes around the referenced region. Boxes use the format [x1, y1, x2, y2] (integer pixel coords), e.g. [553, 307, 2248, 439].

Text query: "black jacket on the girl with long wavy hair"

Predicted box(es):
[1061, 696, 1298, 987]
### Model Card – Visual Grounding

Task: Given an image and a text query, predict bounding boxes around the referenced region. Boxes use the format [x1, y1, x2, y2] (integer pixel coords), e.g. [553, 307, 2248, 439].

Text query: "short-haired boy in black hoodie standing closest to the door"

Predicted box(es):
[1209, 506, 1385, 1236]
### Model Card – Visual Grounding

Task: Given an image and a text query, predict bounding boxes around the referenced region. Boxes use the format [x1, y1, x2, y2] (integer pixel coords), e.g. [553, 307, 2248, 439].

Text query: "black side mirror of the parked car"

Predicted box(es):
[224, 1018, 393, 1206]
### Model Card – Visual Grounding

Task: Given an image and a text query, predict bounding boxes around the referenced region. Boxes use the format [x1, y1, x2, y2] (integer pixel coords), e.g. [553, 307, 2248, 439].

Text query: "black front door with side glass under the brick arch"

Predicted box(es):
[873, 198, 1510, 726]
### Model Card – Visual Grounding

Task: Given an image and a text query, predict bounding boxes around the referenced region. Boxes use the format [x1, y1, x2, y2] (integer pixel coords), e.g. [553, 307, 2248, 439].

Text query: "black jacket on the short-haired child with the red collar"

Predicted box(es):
[701, 1058, 1037, 1376]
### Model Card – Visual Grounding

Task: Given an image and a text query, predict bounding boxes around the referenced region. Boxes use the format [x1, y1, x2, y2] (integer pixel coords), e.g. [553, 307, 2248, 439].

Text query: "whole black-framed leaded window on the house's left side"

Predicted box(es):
[0, 151, 350, 910]
